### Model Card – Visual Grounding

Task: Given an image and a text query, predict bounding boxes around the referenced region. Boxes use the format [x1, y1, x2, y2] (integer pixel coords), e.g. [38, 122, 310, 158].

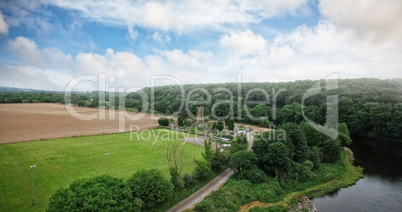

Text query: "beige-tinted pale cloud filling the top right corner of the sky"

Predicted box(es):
[319, 0, 402, 43]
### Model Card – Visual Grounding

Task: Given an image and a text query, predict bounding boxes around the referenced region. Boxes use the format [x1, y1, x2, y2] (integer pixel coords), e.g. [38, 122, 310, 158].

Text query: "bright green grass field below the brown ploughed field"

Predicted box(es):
[0, 129, 203, 211]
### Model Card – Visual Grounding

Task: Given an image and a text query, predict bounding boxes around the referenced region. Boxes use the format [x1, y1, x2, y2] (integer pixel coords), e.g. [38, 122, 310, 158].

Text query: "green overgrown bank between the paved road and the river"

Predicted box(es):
[192, 151, 363, 212]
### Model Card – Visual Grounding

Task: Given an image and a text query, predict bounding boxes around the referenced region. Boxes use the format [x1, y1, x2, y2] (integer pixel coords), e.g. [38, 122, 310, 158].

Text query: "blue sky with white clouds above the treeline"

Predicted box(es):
[0, 0, 402, 91]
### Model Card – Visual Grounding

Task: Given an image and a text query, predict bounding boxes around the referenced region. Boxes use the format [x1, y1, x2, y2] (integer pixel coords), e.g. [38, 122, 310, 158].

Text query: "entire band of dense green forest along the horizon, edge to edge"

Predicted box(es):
[0, 79, 402, 140]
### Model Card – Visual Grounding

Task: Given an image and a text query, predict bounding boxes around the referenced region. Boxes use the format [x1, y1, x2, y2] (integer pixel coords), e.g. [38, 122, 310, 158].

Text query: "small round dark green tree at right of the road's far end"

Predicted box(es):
[229, 150, 257, 172]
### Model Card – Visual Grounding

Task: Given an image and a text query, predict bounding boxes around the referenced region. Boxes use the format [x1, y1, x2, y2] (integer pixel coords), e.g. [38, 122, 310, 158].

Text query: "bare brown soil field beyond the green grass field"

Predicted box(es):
[0, 103, 158, 143]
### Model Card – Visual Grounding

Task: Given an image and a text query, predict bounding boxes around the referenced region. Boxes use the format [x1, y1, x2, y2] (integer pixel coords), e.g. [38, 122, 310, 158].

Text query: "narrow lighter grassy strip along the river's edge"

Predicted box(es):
[239, 150, 363, 212]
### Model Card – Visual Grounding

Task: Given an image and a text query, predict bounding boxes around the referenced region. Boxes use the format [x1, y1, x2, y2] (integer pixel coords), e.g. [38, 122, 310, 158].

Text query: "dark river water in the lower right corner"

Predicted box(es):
[312, 138, 402, 212]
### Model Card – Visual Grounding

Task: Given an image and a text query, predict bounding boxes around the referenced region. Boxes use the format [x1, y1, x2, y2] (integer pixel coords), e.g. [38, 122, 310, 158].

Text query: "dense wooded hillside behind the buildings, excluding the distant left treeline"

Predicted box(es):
[136, 79, 402, 140]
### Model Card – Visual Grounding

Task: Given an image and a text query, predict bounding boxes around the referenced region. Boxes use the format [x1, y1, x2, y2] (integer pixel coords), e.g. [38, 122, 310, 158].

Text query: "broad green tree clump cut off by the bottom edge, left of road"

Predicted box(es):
[47, 175, 133, 211]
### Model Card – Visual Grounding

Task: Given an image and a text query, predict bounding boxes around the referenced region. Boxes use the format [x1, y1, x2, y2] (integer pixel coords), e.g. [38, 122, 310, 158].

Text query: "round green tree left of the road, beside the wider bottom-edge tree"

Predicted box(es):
[127, 169, 173, 209]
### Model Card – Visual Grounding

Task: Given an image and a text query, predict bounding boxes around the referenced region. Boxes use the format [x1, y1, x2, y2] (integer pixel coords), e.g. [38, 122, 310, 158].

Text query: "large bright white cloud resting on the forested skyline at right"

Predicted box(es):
[231, 21, 402, 81]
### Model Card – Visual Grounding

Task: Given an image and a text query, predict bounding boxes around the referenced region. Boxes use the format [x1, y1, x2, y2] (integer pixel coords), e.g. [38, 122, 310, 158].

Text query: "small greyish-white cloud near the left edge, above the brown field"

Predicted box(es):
[8, 36, 44, 66]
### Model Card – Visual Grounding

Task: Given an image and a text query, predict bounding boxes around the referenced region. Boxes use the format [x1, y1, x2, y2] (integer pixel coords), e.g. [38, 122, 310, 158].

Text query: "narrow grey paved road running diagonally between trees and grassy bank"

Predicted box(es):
[167, 169, 234, 212]
